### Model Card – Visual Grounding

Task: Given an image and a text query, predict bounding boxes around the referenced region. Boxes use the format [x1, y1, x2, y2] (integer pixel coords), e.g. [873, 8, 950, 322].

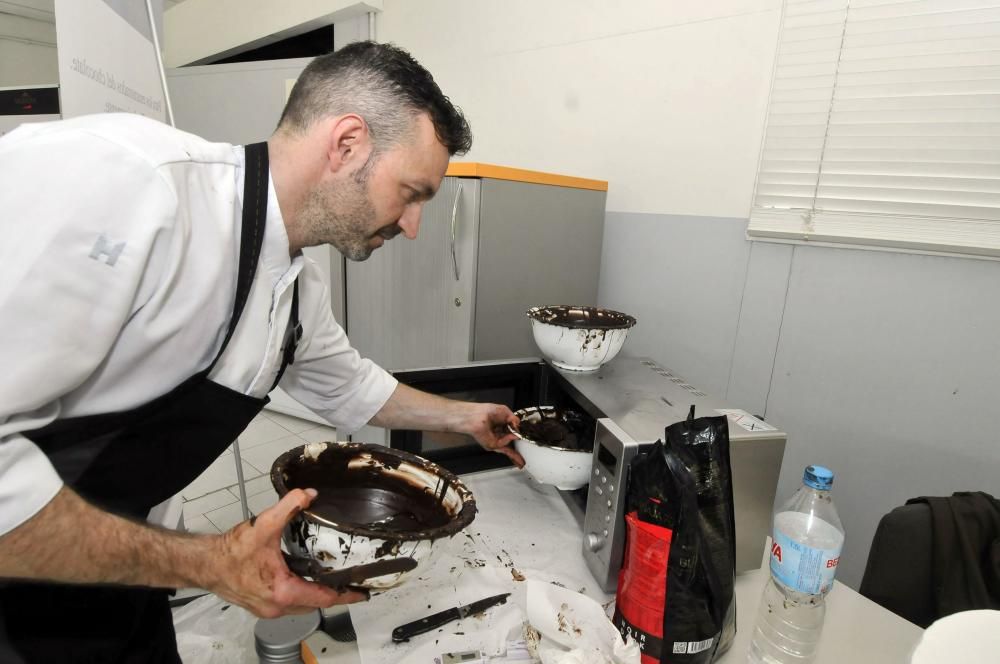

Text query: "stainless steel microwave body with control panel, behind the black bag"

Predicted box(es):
[572, 357, 786, 590]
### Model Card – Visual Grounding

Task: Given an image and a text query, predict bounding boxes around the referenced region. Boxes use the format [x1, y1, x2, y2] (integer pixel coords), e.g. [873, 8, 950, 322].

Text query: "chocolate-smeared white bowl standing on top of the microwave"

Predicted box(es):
[527, 305, 635, 371]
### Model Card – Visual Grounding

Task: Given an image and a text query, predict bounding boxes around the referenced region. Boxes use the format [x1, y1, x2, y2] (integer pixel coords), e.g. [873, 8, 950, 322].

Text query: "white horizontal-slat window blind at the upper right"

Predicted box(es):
[748, 0, 1000, 257]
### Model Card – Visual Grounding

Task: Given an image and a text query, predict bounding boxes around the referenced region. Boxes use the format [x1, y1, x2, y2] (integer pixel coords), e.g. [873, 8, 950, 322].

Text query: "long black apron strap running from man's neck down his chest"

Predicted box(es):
[208, 142, 268, 372]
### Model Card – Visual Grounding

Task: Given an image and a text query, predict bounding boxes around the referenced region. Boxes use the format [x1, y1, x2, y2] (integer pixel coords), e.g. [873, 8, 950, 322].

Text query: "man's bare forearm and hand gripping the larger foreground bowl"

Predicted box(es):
[0, 486, 366, 618]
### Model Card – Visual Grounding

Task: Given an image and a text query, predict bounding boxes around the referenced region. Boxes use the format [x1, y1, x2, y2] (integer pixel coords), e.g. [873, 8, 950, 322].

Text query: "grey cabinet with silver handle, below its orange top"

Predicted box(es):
[345, 169, 606, 369]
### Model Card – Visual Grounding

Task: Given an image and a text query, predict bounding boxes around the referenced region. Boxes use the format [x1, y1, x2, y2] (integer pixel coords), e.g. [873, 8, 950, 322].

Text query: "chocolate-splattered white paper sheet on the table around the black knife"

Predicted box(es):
[350, 470, 613, 664]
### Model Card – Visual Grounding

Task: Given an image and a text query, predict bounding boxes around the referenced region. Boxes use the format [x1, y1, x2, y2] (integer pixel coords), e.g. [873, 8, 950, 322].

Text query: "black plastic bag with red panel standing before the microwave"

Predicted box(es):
[614, 406, 736, 664]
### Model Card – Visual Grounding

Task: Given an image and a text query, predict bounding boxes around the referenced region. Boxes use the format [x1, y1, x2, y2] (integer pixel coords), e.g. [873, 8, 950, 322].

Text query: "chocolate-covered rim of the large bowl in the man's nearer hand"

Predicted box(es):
[271, 442, 477, 542]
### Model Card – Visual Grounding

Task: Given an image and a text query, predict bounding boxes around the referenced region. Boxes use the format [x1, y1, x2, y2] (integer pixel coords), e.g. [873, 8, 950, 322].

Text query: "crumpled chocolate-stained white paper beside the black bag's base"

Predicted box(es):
[527, 579, 640, 664]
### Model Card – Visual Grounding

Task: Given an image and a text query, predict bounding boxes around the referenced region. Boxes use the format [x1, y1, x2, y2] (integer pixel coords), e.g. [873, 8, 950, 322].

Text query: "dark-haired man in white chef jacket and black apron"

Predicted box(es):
[0, 42, 523, 662]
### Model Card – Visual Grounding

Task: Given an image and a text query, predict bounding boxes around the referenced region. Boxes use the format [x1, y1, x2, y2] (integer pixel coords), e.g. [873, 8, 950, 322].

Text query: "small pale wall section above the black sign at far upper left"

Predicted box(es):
[0, 13, 59, 88]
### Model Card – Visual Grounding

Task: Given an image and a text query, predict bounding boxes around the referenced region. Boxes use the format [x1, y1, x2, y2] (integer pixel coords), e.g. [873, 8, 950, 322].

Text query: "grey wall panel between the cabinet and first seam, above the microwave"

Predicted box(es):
[598, 212, 750, 400]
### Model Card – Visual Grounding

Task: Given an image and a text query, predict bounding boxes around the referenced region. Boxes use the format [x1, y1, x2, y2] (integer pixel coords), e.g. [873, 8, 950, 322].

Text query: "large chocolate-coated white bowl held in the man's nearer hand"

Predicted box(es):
[271, 443, 476, 590]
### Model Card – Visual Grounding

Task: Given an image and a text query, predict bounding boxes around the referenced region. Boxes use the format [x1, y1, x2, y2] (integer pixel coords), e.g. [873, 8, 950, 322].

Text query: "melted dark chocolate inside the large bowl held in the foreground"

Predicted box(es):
[284, 446, 453, 533]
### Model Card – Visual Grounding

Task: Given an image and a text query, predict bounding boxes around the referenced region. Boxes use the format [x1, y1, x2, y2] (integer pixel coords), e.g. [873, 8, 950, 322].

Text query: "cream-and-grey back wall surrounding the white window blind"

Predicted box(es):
[378, 0, 1000, 587]
